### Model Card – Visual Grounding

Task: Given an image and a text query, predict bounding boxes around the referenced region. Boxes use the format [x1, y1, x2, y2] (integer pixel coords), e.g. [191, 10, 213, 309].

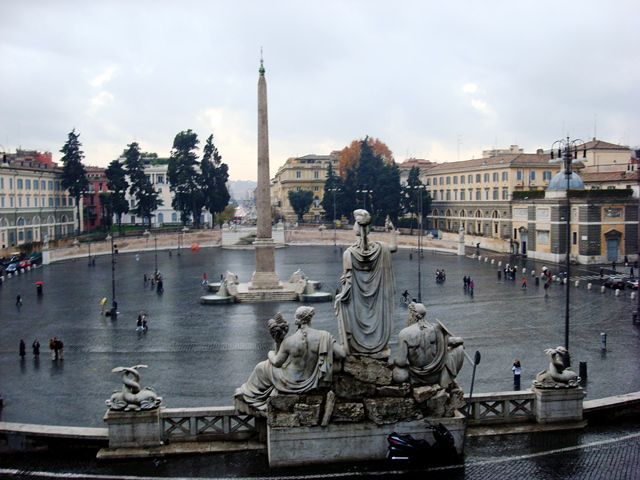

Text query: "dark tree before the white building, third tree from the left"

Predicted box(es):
[123, 142, 162, 225]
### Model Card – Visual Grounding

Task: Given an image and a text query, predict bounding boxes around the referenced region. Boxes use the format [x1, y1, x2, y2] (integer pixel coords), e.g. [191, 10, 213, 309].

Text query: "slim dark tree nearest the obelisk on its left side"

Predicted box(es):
[200, 135, 235, 228]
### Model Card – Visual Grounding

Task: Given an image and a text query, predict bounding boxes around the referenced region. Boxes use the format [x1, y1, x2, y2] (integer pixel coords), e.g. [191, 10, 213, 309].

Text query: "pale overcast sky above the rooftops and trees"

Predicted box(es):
[0, 0, 640, 180]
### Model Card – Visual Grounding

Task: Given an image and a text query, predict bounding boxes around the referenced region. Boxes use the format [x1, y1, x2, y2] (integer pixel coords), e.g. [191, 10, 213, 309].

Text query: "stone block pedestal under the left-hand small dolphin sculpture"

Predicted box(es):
[103, 408, 162, 449]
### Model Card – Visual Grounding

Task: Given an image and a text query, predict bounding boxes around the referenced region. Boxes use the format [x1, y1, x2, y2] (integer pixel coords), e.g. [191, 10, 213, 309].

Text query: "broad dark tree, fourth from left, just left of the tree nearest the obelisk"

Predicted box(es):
[167, 129, 205, 228]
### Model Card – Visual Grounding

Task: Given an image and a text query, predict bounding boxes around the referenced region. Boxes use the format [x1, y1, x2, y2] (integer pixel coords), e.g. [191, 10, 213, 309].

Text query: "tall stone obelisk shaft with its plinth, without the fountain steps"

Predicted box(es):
[249, 58, 282, 290]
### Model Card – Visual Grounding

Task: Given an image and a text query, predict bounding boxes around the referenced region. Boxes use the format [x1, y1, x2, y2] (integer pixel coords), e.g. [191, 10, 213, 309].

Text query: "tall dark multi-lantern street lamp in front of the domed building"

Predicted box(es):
[551, 137, 586, 360]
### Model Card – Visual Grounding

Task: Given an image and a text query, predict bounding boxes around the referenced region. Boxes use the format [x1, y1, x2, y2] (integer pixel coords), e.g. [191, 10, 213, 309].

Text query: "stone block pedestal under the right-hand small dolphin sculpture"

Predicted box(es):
[531, 386, 585, 423]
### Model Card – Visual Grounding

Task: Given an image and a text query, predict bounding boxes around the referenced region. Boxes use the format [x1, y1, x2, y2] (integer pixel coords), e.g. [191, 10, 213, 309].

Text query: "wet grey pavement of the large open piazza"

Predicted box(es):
[0, 246, 640, 426]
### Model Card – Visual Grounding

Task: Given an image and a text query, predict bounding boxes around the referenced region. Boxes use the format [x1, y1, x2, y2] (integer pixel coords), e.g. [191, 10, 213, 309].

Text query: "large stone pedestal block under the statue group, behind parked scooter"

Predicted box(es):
[267, 412, 465, 467]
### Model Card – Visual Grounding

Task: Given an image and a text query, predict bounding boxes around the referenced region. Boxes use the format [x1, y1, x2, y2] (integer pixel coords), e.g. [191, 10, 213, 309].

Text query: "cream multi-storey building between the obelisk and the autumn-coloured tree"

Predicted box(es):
[271, 152, 339, 222]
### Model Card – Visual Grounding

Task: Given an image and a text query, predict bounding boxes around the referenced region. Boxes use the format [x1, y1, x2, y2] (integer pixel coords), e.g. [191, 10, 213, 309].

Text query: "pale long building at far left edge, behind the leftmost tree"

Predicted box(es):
[0, 150, 76, 254]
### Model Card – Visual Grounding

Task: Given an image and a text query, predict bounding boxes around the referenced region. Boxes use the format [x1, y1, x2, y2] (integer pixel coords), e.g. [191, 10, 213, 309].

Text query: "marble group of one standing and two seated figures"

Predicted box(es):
[235, 210, 464, 421]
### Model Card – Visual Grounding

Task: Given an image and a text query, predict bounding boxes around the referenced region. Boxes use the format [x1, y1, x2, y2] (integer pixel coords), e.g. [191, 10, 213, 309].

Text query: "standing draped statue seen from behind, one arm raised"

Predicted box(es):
[334, 210, 398, 357]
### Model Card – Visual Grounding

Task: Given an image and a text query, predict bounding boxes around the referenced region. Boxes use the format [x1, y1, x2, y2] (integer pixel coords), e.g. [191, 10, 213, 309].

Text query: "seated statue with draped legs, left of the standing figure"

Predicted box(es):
[235, 307, 344, 412]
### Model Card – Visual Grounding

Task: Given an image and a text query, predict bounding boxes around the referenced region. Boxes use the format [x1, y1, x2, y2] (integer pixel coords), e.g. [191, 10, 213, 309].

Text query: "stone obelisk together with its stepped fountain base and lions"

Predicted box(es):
[200, 59, 331, 304]
